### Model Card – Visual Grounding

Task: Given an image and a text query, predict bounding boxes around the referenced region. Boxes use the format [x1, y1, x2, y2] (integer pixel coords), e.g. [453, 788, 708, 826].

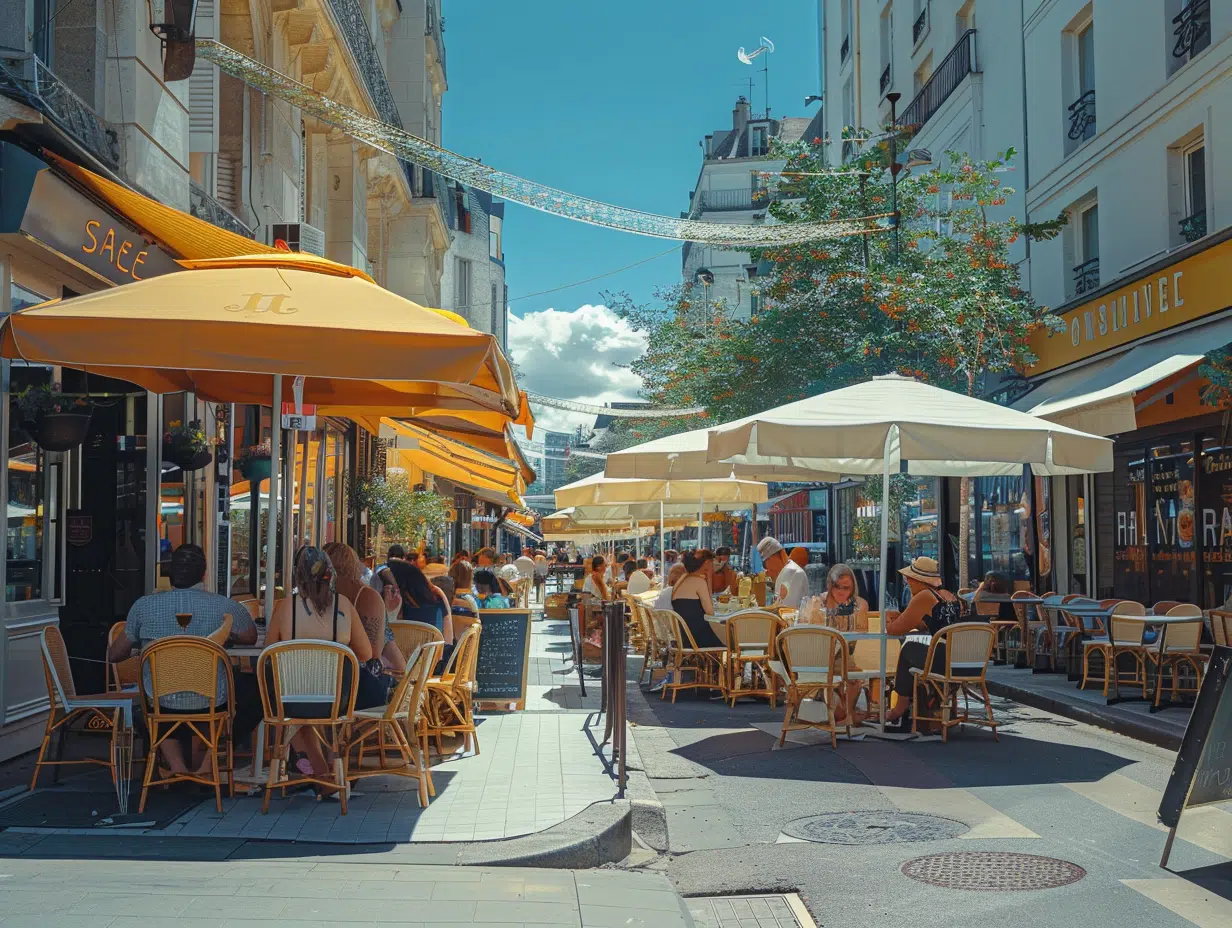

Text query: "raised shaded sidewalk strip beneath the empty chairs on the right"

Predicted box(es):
[988, 667, 1189, 751]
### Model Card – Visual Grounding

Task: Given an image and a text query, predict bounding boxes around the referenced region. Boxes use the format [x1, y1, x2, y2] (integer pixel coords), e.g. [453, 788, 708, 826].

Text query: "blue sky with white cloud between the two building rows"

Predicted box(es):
[442, 0, 819, 428]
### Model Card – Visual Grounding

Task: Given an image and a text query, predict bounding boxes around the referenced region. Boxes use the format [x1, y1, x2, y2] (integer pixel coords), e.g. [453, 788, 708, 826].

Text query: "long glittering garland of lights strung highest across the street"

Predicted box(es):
[197, 38, 890, 248]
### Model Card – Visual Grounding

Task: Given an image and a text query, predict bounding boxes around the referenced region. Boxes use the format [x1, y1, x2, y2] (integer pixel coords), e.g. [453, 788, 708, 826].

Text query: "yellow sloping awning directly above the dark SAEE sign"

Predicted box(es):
[44, 152, 280, 258]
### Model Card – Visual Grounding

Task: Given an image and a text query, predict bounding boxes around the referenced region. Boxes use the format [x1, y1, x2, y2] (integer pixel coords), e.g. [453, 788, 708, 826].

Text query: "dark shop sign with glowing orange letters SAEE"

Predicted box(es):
[21, 170, 182, 283]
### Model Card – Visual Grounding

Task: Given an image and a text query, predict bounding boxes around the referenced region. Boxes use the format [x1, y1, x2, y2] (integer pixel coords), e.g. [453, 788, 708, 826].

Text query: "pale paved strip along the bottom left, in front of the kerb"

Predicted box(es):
[0, 859, 694, 928]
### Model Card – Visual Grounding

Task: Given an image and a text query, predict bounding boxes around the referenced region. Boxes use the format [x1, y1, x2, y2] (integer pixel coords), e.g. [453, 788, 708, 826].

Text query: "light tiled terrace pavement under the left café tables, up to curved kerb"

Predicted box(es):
[0, 616, 616, 844]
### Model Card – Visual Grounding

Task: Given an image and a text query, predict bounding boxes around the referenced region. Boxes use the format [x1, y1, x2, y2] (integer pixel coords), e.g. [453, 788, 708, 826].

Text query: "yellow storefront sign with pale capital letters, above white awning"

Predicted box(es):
[1030, 240, 1232, 377]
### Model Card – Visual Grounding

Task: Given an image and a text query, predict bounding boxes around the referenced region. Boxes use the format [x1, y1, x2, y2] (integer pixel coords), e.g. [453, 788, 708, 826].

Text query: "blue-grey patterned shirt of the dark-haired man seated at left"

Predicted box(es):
[124, 587, 255, 711]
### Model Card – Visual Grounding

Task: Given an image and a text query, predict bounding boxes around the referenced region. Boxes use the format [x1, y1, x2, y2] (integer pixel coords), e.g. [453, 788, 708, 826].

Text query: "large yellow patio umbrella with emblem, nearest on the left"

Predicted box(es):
[0, 253, 521, 418]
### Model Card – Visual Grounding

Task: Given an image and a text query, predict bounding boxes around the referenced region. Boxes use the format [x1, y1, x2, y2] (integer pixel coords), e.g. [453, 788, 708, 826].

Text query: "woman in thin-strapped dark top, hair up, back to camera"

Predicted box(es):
[265, 547, 386, 795]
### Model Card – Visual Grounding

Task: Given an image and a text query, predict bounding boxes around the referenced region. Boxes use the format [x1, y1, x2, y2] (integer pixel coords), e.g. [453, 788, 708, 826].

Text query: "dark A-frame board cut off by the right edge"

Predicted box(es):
[1159, 647, 1232, 866]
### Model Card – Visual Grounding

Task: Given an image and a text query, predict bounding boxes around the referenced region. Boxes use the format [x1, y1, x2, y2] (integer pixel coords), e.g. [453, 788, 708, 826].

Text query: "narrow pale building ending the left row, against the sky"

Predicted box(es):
[441, 184, 509, 346]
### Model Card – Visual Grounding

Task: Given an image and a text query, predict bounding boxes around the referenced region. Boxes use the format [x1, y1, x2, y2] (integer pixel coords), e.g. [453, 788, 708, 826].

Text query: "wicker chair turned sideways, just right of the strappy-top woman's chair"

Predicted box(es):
[346, 641, 445, 808]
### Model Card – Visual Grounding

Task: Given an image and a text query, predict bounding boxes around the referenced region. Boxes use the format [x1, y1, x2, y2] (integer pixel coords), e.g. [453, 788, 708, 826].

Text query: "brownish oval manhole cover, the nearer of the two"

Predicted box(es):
[902, 850, 1087, 892]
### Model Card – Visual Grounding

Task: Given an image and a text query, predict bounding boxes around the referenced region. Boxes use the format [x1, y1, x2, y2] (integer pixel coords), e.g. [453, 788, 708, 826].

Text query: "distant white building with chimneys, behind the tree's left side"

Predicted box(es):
[681, 96, 809, 319]
